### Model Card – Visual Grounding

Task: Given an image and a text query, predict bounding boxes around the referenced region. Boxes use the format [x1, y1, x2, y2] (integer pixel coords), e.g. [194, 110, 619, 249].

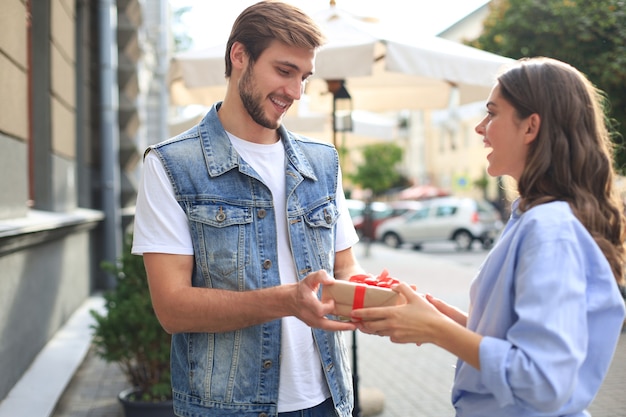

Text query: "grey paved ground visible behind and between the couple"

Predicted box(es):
[50, 245, 626, 417]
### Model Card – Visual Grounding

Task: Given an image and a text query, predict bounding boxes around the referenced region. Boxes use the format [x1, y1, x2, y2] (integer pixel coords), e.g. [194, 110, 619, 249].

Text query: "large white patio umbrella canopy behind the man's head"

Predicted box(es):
[170, 5, 512, 114]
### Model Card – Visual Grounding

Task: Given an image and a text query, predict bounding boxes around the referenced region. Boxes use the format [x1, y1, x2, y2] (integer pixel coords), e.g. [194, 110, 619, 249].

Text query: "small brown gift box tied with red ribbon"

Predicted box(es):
[322, 272, 404, 321]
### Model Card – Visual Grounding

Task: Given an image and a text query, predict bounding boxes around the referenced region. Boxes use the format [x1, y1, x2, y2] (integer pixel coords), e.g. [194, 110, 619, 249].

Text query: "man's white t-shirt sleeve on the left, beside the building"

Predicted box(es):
[132, 152, 194, 255]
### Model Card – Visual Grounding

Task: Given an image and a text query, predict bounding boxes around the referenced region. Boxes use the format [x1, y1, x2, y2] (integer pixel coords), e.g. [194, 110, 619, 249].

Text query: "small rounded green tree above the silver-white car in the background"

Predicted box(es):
[349, 143, 404, 195]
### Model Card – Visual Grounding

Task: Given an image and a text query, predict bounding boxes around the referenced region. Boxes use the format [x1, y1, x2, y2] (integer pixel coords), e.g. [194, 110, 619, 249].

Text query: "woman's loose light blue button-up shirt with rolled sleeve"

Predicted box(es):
[452, 201, 625, 417]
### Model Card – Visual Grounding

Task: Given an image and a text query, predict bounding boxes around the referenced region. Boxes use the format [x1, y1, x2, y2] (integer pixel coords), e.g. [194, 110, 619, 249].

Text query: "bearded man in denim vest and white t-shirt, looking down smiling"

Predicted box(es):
[133, 2, 363, 417]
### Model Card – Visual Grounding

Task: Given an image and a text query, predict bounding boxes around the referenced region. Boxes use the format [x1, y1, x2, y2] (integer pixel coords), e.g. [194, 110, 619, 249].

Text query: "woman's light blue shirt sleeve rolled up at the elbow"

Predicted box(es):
[480, 216, 589, 412]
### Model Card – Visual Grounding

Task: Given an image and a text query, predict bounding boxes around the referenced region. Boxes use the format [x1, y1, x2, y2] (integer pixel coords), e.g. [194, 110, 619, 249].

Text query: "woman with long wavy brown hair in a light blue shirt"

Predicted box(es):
[353, 58, 625, 417]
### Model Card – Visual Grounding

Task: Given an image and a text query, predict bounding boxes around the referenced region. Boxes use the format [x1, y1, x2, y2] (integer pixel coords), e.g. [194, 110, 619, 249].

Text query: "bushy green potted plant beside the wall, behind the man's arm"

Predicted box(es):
[91, 234, 174, 417]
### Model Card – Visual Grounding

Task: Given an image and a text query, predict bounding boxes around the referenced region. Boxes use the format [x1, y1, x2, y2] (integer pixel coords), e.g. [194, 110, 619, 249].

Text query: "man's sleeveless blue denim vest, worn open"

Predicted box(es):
[151, 103, 353, 417]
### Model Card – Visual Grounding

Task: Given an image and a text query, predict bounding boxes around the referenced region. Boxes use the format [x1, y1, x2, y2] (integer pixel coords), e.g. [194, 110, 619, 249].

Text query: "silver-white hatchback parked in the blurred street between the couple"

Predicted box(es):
[375, 197, 502, 250]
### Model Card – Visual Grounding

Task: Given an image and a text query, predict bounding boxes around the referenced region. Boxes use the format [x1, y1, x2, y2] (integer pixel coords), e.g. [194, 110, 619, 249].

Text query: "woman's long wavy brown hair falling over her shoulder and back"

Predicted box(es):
[498, 58, 625, 284]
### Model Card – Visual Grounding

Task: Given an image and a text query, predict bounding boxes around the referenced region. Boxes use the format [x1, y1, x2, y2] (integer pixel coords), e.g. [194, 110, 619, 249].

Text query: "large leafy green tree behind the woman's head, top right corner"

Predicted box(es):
[466, 0, 626, 173]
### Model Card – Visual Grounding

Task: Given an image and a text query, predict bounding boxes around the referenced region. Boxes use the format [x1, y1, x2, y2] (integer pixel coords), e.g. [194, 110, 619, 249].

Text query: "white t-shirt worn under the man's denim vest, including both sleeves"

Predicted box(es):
[132, 134, 358, 412]
